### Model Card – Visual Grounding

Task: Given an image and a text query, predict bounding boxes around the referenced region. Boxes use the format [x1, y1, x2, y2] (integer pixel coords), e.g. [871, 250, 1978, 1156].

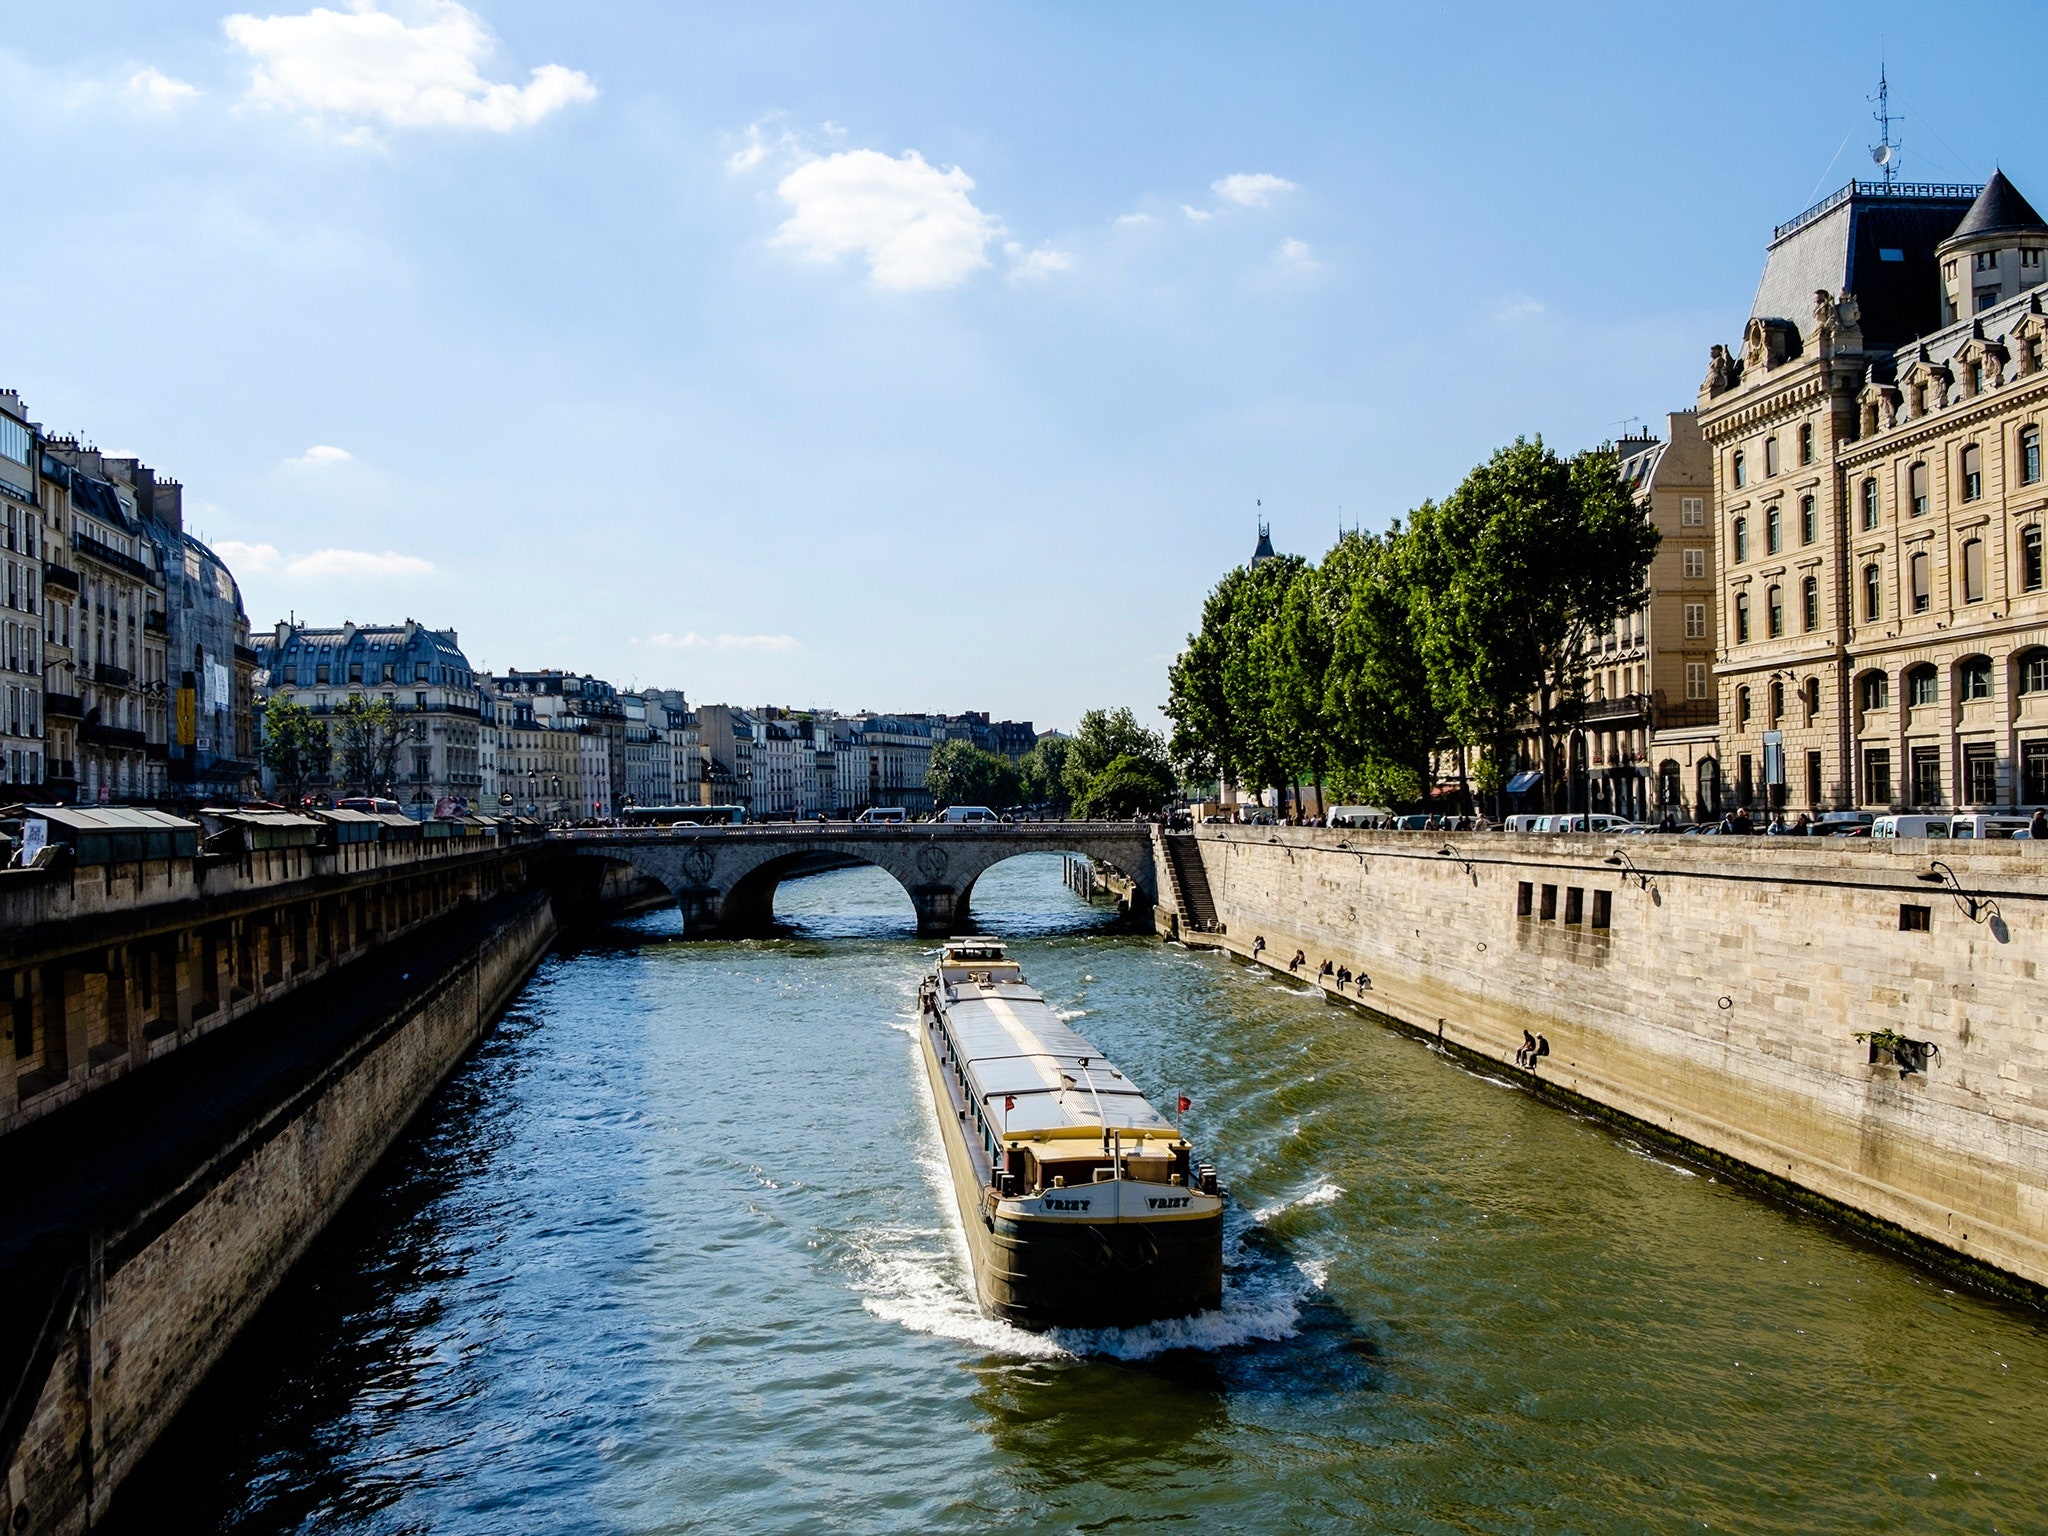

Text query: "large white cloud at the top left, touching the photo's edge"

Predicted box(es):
[221, 0, 598, 137]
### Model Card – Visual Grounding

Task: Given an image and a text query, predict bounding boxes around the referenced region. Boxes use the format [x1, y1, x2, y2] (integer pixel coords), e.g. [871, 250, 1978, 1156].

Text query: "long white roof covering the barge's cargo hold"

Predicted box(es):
[940, 974, 1174, 1137]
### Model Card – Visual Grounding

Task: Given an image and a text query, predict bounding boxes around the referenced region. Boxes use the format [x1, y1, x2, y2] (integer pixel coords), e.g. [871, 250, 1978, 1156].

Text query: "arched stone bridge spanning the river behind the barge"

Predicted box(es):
[549, 821, 1159, 934]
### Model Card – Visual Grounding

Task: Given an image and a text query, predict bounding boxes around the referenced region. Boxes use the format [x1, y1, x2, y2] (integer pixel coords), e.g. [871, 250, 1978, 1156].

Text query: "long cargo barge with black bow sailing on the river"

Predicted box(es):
[918, 938, 1223, 1327]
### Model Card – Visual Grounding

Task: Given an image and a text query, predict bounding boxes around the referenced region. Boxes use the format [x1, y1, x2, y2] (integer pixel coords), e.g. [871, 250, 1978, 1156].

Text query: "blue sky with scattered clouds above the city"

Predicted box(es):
[0, 0, 2048, 727]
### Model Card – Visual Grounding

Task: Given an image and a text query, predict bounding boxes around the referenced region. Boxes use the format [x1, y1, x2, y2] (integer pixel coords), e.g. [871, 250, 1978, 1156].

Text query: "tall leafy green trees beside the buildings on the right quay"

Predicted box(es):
[1165, 438, 1657, 807]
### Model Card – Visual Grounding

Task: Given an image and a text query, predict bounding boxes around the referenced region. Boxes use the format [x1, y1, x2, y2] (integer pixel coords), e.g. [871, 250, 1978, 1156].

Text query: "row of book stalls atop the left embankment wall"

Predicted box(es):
[0, 805, 547, 870]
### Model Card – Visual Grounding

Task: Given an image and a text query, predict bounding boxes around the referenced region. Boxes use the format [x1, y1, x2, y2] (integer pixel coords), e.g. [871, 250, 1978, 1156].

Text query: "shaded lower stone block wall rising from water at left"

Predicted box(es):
[0, 895, 555, 1534]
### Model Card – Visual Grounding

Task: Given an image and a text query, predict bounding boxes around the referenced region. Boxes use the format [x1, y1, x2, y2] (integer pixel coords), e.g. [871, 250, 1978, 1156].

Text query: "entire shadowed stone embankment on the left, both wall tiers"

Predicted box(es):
[0, 846, 555, 1534]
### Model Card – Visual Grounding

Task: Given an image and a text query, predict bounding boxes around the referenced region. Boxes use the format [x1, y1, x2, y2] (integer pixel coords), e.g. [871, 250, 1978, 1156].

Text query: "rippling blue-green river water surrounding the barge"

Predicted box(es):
[117, 856, 2048, 1534]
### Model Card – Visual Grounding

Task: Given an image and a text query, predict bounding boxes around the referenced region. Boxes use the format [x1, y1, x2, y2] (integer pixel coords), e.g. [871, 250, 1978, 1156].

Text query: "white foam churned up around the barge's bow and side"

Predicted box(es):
[854, 1024, 1318, 1360]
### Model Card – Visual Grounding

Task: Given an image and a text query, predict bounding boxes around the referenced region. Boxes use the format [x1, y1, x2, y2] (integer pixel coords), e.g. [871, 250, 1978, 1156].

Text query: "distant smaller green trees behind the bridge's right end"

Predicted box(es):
[924, 709, 1176, 819]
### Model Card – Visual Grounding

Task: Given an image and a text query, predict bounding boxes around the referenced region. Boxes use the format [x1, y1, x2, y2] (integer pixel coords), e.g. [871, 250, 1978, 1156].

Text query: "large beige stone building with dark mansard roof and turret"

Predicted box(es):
[1700, 174, 2048, 809]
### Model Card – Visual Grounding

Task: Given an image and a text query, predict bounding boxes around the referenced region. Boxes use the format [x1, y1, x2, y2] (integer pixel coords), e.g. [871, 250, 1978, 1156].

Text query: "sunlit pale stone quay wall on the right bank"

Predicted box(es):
[1194, 827, 2048, 1303]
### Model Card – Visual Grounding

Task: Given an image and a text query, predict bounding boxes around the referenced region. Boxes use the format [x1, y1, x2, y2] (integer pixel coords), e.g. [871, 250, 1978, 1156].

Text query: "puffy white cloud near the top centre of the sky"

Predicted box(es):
[774, 150, 1001, 289]
